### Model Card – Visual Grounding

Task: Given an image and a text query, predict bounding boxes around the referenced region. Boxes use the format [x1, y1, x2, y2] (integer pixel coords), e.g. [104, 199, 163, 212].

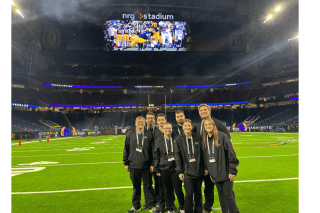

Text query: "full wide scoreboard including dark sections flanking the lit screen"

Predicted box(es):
[62, 19, 246, 53]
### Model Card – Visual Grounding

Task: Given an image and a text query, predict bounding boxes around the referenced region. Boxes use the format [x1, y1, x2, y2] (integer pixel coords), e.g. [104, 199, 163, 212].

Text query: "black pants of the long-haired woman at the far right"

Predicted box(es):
[216, 180, 239, 213]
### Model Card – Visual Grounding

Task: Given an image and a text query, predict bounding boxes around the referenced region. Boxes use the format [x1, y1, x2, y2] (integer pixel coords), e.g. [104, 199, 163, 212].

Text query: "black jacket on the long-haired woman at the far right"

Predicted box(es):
[201, 132, 239, 182]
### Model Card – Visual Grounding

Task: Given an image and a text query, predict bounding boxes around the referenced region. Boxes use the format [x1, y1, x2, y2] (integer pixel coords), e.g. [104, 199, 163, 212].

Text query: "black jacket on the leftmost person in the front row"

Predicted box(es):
[123, 130, 154, 169]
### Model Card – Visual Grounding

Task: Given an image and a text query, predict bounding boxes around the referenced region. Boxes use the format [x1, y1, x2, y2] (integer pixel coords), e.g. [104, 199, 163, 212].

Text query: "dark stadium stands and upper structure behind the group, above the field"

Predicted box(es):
[12, 0, 299, 137]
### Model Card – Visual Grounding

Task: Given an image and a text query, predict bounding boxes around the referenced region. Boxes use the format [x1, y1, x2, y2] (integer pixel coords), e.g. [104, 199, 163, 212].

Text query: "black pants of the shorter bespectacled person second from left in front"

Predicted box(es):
[160, 170, 184, 211]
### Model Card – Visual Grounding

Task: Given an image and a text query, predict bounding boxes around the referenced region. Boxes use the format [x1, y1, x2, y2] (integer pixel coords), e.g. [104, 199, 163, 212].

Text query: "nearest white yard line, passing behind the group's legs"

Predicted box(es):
[11, 178, 299, 195]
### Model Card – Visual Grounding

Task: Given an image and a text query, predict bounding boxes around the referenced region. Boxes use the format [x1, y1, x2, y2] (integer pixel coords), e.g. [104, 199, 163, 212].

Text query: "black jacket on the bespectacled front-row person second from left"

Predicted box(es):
[153, 136, 176, 173]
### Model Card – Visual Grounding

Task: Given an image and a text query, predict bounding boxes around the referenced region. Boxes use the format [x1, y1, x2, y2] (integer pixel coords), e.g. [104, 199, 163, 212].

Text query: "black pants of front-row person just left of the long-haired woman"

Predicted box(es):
[184, 178, 203, 213]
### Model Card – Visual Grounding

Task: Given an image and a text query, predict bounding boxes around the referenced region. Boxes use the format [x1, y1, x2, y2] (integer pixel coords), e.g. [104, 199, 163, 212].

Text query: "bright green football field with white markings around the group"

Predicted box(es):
[11, 133, 299, 213]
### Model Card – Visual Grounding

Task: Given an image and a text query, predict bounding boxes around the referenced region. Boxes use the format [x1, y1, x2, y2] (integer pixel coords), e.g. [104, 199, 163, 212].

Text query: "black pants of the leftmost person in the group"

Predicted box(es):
[130, 169, 157, 209]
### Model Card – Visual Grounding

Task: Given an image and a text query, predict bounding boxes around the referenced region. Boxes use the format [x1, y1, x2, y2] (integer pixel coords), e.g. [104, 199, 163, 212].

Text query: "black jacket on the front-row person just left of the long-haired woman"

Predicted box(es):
[174, 133, 206, 178]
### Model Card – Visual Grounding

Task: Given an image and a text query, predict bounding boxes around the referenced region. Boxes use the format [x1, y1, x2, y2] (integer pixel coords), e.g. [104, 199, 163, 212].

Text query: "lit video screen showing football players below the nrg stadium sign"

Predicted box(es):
[104, 20, 189, 51]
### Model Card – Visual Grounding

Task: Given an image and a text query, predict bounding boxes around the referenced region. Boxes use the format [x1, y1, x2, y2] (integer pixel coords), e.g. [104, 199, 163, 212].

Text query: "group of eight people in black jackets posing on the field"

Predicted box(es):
[123, 104, 239, 213]
